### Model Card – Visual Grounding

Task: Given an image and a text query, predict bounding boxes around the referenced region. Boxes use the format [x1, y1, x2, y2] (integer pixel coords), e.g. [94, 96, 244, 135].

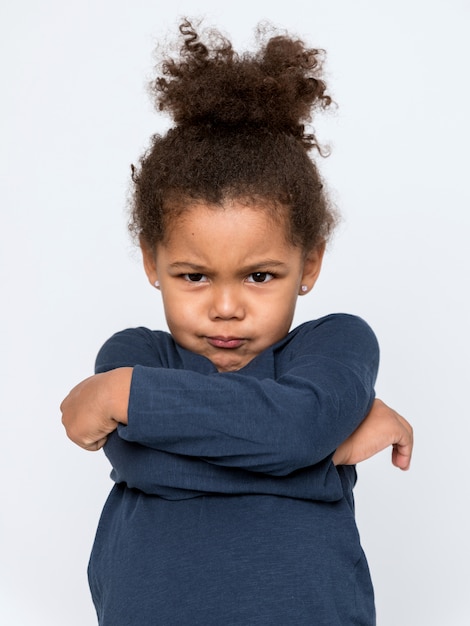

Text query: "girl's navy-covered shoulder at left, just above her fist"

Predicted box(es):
[95, 327, 177, 373]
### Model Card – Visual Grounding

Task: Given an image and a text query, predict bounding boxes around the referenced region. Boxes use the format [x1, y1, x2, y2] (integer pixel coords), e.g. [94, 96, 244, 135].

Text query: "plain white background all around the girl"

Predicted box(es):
[0, 0, 470, 626]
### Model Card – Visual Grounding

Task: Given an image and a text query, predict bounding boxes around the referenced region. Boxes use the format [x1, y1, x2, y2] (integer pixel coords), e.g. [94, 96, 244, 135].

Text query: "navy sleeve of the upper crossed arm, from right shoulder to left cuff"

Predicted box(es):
[118, 315, 379, 476]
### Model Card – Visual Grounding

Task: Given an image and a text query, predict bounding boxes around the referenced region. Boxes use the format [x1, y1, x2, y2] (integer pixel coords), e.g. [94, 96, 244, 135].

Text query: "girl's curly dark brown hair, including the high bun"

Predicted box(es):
[129, 20, 336, 251]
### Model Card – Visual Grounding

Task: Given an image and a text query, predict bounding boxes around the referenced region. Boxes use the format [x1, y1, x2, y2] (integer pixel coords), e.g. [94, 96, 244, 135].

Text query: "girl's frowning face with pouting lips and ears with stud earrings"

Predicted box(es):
[142, 201, 323, 372]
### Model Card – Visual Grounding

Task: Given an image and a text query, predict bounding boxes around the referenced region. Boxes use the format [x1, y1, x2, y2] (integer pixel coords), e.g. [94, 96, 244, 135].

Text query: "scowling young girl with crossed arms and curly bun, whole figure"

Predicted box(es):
[61, 22, 412, 626]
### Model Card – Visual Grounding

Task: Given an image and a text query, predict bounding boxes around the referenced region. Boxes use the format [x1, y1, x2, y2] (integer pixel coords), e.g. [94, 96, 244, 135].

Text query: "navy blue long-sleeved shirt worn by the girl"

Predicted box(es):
[89, 314, 379, 626]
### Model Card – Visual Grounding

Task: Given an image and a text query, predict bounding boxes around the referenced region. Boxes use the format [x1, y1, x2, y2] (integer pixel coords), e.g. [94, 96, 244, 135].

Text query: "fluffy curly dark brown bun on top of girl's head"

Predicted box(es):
[152, 20, 331, 145]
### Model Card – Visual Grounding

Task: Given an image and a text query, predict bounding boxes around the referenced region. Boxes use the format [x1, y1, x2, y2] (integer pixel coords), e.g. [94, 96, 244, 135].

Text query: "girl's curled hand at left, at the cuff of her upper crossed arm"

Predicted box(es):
[60, 367, 132, 450]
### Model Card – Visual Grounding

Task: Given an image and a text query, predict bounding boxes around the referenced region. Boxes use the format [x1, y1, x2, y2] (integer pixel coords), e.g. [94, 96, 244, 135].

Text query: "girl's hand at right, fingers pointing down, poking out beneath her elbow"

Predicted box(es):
[333, 399, 413, 470]
